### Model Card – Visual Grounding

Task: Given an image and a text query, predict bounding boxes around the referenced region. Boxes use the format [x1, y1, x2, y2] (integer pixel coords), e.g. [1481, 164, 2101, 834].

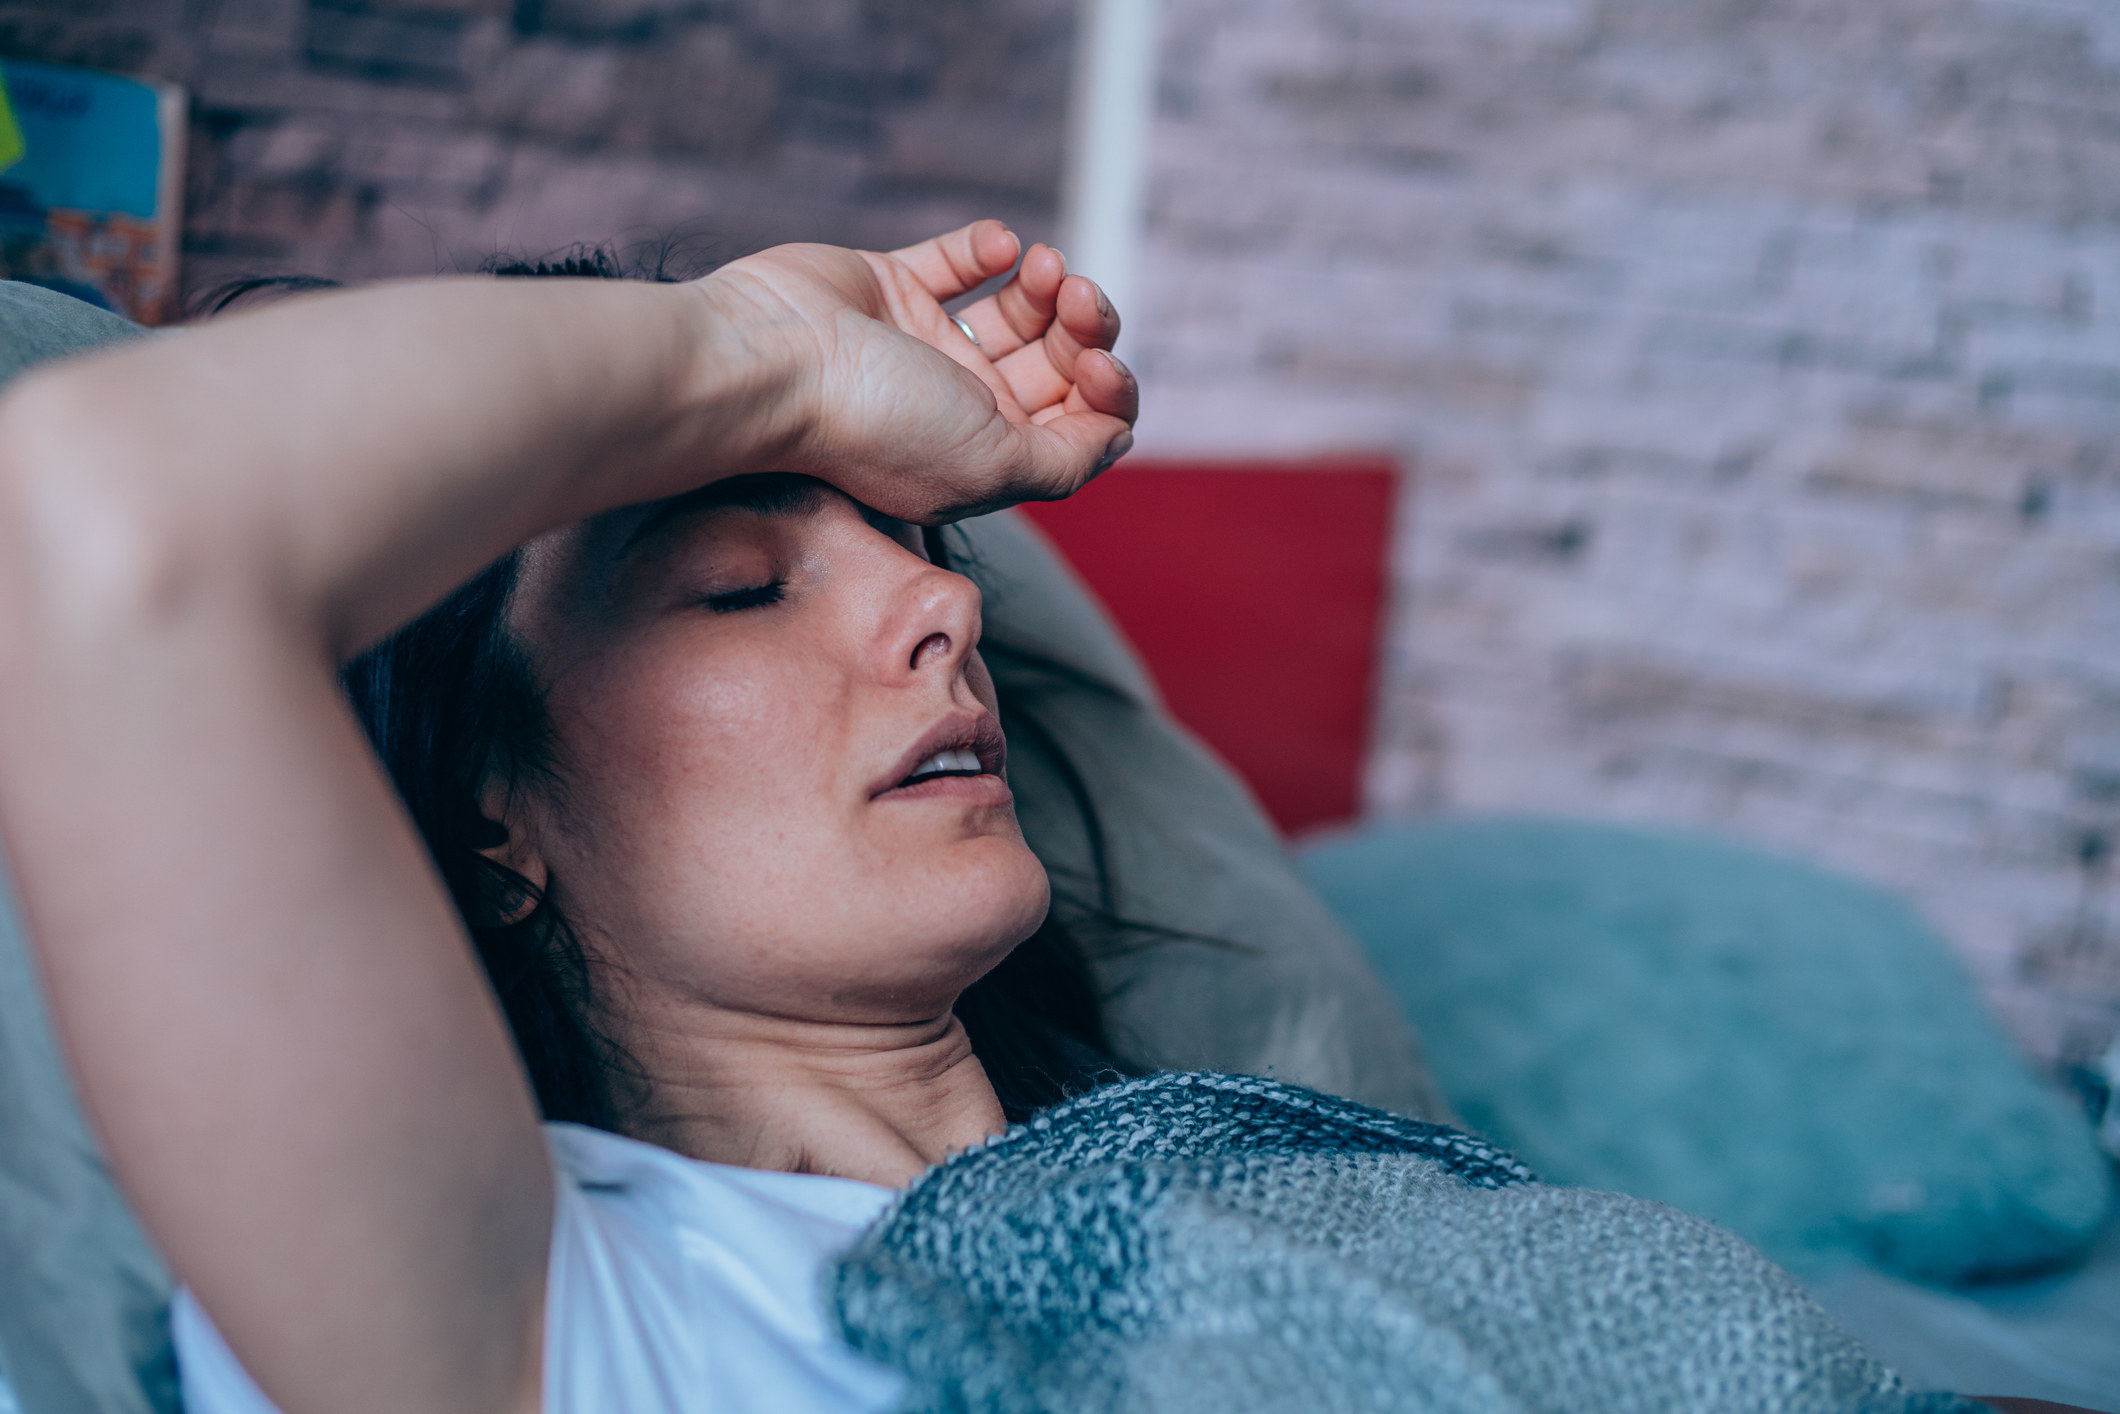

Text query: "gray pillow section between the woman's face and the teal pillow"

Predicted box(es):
[950, 511, 1450, 1119]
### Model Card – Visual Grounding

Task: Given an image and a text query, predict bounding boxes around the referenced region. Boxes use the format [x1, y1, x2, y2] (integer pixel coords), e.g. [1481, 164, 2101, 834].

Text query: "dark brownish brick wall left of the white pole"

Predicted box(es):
[0, 0, 1073, 295]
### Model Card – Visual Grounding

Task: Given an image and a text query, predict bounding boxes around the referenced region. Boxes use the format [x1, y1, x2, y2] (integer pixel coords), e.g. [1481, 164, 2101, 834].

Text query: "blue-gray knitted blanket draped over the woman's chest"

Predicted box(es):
[829, 1073, 1984, 1414]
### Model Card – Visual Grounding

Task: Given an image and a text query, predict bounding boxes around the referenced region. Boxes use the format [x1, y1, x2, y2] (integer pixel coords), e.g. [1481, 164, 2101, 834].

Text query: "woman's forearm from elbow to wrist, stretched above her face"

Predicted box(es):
[0, 280, 795, 653]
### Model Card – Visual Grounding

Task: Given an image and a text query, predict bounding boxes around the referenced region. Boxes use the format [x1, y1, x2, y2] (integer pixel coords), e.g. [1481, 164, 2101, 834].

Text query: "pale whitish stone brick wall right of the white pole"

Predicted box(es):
[1130, 0, 2120, 1056]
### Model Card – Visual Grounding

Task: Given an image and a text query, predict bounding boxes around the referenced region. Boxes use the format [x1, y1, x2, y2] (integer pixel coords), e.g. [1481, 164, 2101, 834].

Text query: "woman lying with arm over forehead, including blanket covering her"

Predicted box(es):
[0, 223, 2052, 1414]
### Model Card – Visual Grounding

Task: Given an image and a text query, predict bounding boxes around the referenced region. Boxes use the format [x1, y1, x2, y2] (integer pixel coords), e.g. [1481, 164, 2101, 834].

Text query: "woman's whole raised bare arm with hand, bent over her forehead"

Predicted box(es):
[0, 223, 1132, 1414]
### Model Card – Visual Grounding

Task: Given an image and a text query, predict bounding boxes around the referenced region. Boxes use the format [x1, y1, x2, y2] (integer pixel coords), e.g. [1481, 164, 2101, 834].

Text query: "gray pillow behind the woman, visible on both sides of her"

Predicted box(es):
[0, 282, 1448, 1414]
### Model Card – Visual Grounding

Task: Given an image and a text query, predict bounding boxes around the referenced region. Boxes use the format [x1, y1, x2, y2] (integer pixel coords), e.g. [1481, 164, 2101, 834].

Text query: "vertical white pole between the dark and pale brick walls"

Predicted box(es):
[1060, 0, 1158, 343]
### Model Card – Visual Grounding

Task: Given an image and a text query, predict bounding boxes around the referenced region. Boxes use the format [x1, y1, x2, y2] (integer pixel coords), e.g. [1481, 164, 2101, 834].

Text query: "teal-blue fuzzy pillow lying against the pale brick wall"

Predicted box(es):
[1302, 820, 2112, 1280]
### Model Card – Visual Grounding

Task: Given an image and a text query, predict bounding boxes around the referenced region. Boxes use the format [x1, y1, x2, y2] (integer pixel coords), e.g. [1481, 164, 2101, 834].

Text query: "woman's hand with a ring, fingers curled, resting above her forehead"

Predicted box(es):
[700, 220, 1138, 524]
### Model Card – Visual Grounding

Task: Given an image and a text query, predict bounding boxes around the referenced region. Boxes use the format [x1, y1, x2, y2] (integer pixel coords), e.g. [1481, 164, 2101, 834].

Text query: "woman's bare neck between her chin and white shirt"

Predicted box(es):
[606, 1005, 1005, 1187]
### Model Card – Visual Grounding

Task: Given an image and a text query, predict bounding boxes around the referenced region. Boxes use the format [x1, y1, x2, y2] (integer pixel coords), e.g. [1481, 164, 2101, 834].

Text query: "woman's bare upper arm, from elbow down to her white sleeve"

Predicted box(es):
[0, 615, 551, 1414]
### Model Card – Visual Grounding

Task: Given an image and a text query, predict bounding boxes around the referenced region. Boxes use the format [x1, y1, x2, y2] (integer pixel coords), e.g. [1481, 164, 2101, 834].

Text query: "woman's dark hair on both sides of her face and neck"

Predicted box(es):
[339, 252, 1155, 1128]
